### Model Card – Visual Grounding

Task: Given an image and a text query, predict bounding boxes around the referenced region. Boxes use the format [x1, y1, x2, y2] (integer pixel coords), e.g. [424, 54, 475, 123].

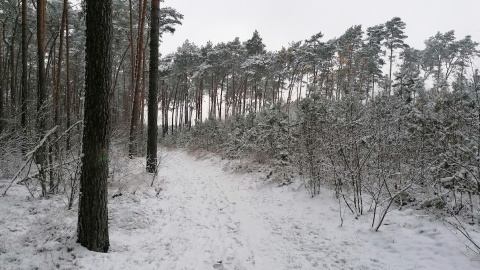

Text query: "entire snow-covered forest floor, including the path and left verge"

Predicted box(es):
[0, 151, 480, 269]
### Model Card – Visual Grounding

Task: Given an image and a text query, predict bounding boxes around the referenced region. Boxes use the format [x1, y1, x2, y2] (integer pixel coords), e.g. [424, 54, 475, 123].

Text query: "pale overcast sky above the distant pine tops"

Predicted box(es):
[160, 0, 480, 54]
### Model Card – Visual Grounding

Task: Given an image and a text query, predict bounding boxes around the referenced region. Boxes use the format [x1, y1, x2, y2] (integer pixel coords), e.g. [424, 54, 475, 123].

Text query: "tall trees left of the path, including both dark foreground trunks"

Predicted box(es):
[0, 0, 183, 252]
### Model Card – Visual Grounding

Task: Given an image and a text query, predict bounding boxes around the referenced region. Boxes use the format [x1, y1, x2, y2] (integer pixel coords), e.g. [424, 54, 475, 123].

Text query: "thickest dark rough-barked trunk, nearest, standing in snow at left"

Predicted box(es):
[77, 0, 112, 252]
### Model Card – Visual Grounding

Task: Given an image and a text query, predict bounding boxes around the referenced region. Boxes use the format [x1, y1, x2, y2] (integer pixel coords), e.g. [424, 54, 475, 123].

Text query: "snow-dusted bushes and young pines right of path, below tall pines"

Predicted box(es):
[164, 75, 480, 234]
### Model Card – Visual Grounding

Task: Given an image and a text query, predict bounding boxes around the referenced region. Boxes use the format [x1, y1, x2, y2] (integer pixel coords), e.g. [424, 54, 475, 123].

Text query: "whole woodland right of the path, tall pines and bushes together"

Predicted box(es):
[160, 18, 480, 232]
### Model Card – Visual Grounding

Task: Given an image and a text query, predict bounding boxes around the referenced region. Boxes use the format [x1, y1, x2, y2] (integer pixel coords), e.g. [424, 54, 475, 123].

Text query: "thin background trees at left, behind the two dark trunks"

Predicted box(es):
[0, 0, 183, 157]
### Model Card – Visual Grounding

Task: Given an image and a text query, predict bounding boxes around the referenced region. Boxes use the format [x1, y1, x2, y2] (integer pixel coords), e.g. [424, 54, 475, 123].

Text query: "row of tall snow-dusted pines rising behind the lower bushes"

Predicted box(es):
[160, 18, 478, 134]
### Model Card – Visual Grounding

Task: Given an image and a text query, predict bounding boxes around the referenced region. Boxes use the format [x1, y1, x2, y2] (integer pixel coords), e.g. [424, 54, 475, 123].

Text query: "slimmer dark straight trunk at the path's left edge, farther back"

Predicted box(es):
[147, 0, 160, 173]
